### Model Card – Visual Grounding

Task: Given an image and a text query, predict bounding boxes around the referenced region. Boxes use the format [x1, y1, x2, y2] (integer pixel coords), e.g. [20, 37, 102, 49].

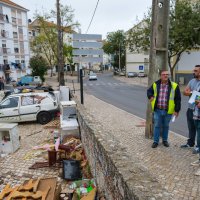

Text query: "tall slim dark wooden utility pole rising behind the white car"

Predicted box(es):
[56, 0, 65, 85]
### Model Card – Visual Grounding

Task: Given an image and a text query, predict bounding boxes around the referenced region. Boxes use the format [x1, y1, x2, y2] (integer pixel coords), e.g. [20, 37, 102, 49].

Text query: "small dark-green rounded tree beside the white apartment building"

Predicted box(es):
[30, 55, 48, 82]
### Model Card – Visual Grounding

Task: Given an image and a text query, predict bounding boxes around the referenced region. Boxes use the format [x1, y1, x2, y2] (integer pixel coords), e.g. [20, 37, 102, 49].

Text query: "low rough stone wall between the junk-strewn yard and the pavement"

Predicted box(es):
[76, 100, 173, 200]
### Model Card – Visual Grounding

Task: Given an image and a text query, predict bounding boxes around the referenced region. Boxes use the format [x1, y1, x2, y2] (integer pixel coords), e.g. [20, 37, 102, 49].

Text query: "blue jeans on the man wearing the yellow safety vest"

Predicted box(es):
[154, 109, 172, 144]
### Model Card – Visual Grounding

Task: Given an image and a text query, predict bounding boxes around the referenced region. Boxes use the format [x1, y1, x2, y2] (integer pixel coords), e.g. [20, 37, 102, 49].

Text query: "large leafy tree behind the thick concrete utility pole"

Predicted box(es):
[127, 0, 200, 79]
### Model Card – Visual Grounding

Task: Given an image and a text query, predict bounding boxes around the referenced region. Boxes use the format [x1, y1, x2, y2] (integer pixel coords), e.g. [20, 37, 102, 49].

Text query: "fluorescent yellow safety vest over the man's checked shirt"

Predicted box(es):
[151, 82, 178, 114]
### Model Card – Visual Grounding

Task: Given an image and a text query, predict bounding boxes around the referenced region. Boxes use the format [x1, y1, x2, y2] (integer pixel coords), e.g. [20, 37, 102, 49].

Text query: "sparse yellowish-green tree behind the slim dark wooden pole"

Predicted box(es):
[31, 5, 79, 79]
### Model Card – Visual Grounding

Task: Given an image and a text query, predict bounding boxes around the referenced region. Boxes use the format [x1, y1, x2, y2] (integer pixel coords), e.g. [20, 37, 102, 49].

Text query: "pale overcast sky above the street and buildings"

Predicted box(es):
[11, 0, 152, 38]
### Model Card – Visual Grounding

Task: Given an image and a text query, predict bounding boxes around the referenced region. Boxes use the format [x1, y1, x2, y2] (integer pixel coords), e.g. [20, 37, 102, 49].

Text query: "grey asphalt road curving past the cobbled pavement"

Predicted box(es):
[84, 73, 188, 136]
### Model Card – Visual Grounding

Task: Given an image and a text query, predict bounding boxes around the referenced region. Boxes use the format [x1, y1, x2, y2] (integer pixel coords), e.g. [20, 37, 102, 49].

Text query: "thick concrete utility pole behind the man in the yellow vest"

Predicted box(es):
[145, 0, 170, 138]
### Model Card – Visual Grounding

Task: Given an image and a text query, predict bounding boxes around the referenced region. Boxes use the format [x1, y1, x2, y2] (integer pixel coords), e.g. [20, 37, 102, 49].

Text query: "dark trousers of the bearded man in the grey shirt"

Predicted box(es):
[186, 108, 196, 146]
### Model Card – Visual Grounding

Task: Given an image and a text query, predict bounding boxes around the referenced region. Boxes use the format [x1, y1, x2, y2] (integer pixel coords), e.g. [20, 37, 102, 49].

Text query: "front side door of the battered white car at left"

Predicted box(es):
[0, 97, 20, 122]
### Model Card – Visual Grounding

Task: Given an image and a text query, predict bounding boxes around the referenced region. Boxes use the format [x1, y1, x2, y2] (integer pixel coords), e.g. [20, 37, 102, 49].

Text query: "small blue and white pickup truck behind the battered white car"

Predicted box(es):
[17, 76, 42, 86]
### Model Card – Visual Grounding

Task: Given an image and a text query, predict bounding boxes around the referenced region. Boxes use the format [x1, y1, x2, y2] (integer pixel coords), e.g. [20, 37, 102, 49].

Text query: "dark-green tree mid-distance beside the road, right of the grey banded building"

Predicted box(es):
[103, 30, 126, 69]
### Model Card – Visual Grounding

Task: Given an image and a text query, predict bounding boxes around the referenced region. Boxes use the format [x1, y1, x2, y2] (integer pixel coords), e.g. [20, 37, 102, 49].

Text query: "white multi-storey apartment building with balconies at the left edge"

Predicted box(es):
[0, 0, 30, 79]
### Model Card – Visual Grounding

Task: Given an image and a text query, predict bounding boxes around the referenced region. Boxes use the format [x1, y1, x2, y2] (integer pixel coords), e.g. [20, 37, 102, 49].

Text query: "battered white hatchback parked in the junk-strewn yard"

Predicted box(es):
[0, 92, 59, 124]
